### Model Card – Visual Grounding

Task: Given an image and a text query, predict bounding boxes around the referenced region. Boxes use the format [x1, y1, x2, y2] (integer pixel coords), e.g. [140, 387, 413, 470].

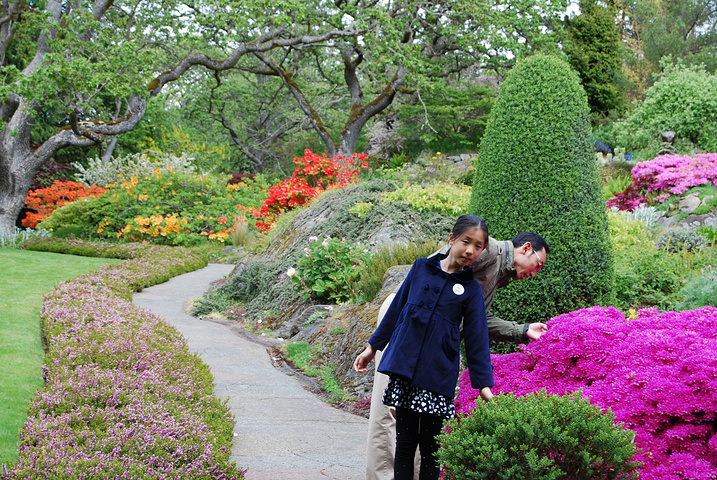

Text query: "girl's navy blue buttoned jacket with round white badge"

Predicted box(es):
[368, 254, 493, 399]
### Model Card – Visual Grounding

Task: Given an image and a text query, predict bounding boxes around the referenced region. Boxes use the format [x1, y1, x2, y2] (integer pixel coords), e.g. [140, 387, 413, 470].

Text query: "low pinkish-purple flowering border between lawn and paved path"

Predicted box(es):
[1, 239, 244, 480]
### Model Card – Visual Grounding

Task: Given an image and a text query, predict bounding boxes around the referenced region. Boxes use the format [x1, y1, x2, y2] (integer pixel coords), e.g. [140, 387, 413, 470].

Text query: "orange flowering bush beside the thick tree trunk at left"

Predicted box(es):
[22, 180, 105, 228]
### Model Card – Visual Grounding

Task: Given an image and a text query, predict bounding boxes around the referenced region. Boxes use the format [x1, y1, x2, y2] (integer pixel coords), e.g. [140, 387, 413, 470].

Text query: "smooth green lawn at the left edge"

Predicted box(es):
[0, 248, 120, 467]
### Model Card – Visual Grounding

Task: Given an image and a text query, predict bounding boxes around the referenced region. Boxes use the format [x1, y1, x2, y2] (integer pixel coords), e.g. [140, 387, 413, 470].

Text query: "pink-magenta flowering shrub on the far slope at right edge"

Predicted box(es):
[607, 153, 717, 210]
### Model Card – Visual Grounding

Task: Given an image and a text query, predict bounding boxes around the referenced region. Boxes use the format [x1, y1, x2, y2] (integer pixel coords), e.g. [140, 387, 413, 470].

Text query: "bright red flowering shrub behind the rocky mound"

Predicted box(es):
[251, 149, 368, 232]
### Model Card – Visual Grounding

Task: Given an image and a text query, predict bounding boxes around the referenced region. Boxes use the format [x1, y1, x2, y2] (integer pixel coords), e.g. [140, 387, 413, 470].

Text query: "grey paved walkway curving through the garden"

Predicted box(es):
[133, 264, 368, 480]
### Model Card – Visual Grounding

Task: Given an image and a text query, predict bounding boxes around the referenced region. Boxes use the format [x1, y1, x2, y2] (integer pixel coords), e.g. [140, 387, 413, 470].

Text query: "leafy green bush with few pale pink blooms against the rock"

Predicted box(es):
[289, 237, 371, 303]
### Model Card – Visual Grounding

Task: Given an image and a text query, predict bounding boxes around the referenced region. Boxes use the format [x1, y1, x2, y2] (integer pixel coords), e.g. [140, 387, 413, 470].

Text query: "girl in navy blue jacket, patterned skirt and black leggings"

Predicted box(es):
[354, 215, 493, 480]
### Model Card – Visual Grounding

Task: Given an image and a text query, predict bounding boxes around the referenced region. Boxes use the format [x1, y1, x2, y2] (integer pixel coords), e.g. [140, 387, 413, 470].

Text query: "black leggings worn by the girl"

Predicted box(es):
[393, 407, 443, 480]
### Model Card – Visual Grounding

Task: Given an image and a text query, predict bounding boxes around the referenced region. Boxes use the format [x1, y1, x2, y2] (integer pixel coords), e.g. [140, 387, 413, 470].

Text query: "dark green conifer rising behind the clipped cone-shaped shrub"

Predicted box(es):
[563, 0, 625, 117]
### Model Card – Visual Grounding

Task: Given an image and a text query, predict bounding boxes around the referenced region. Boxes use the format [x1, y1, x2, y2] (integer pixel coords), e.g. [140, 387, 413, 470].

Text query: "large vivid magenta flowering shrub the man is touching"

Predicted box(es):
[455, 307, 717, 480]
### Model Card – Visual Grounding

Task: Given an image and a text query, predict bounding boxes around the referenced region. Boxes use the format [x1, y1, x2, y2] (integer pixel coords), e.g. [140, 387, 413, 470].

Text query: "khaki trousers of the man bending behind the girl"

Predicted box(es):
[366, 294, 421, 480]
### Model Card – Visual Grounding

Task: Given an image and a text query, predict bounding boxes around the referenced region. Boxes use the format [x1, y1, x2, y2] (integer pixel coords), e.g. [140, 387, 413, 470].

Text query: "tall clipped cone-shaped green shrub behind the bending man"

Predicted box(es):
[468, 55, 614, 322]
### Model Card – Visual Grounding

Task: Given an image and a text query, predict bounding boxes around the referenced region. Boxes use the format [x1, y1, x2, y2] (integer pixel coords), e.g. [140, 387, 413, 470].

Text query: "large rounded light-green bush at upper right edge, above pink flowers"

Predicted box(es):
[614, 59, 717, 158]
